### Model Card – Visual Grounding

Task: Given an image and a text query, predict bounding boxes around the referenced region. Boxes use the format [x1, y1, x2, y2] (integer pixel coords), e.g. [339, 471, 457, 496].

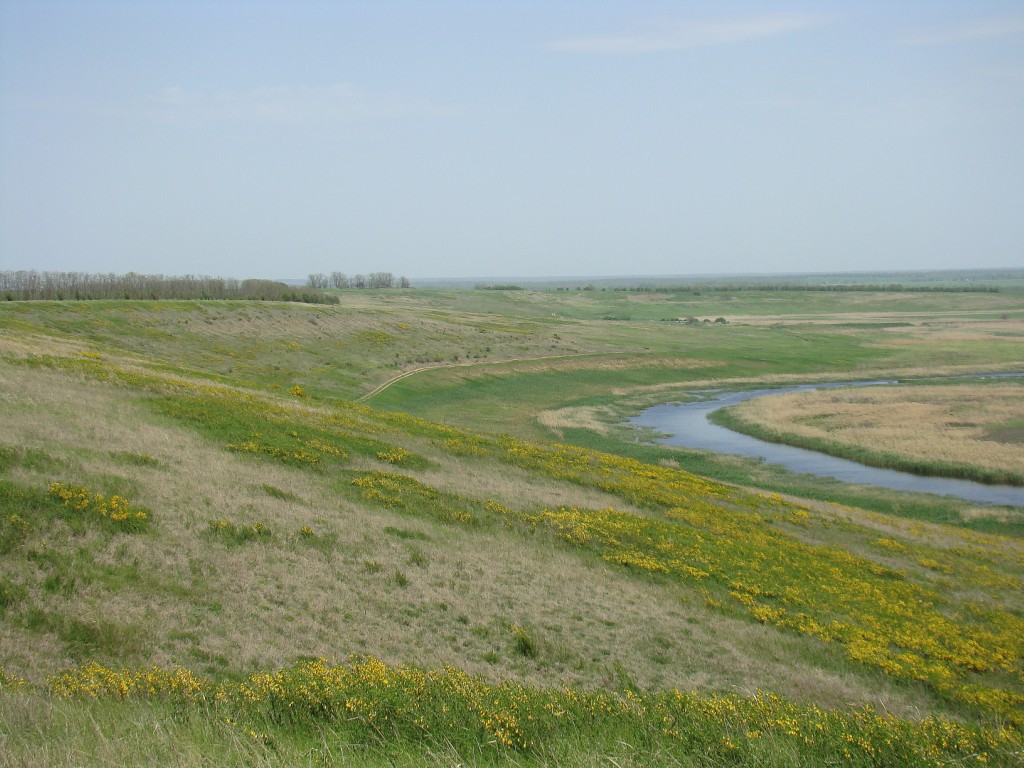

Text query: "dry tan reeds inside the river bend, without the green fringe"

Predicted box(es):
[733, 384, 1024, 481]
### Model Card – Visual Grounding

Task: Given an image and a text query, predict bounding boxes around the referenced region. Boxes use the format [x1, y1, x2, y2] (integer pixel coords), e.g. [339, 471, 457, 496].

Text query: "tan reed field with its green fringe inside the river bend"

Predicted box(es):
[720, 380, 1024, 485]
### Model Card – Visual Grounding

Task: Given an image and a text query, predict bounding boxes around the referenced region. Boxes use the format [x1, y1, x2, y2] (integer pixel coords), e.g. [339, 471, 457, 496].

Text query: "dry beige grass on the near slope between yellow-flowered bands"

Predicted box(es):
[0, 364, 942, 714]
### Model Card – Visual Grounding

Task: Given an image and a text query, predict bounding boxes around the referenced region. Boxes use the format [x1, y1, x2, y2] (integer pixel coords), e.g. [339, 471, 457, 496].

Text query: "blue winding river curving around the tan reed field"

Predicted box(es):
[630, 381, 1024, 507]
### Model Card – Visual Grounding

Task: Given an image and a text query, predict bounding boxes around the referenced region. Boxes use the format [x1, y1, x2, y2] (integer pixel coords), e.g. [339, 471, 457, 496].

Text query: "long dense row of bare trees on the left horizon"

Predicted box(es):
[0, 269, 338, 304]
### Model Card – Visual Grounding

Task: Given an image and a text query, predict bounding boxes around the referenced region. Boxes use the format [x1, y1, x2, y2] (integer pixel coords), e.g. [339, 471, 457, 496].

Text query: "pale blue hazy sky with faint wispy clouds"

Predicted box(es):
[0, 0, 1024, 279]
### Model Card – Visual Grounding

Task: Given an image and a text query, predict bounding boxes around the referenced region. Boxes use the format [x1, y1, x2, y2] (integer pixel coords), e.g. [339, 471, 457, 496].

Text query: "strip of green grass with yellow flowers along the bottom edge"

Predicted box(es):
[0, 658, 1021, 767]
